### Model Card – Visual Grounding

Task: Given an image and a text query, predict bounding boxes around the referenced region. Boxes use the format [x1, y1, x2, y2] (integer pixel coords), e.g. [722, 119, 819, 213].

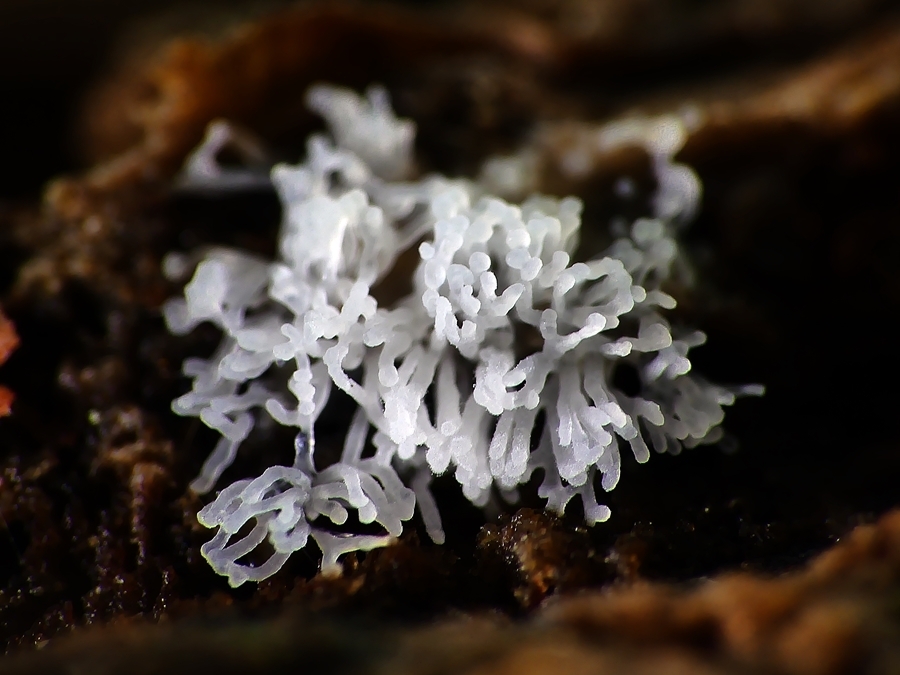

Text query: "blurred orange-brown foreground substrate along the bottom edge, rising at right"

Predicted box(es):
[0, 511, 900, 675]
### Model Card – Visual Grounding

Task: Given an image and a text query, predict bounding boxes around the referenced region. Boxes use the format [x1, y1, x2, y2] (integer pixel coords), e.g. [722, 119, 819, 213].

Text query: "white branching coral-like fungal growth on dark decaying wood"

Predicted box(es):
[164, 87, 758, 585]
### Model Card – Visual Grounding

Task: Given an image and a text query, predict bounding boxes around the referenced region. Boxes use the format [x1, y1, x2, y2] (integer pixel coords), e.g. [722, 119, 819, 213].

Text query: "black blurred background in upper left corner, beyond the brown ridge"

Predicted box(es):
[0, 0, 302, 200]
